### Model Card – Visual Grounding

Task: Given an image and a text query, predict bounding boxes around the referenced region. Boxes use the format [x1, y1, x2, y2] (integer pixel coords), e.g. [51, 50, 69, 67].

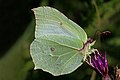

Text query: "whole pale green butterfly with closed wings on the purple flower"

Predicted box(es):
[30, 7, 95, 76]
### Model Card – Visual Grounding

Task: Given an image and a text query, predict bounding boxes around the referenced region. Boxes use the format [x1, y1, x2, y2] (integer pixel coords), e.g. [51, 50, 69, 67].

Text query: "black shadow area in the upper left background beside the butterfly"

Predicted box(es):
[0, 0, 40, 57]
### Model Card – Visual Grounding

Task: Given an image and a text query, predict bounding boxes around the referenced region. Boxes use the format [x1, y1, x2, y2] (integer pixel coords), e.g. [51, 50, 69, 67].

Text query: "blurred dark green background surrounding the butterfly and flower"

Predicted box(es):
[0, 0, 120, 80]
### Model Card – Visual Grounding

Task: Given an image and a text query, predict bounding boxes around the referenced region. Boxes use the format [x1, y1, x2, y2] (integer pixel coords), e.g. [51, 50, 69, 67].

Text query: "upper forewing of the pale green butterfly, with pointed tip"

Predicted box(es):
[33, 7, 87, 42]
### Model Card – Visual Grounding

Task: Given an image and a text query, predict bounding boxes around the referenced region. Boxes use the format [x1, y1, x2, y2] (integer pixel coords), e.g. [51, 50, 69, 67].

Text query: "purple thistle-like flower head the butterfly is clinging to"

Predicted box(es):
[86, 51, 110, 80]
